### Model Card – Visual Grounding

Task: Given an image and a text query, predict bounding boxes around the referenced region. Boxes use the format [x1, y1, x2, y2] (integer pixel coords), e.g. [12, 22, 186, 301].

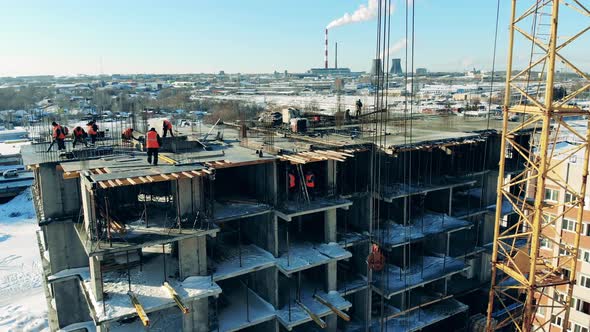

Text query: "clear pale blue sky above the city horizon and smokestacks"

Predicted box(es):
[0, 0, 590, 76]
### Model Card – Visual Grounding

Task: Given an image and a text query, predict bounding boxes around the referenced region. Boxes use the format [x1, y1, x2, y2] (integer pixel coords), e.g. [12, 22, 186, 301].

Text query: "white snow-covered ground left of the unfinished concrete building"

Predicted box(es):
[0, 189, 49, 331]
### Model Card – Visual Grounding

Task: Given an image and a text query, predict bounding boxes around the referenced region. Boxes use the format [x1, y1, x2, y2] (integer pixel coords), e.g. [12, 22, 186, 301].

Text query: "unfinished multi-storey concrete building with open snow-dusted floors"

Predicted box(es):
[23, 120, 526, 331]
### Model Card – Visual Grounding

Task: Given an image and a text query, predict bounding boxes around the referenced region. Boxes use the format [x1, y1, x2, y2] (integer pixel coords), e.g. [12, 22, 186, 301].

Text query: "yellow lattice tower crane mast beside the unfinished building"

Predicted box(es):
[486, 0, 590, 331]
